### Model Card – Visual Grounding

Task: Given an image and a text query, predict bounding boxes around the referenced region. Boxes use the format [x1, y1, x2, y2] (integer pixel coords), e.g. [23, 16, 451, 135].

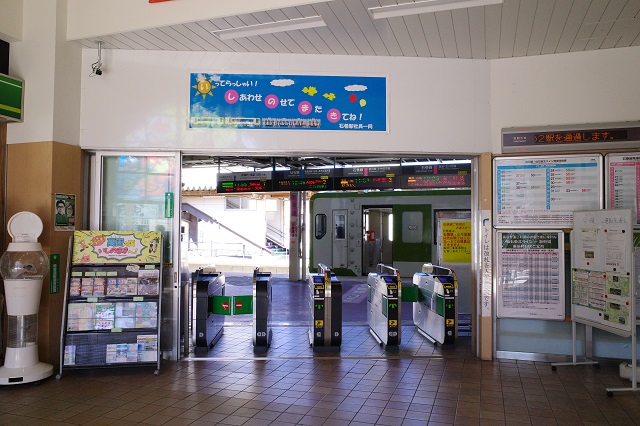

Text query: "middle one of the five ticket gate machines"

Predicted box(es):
[308, 263, 342, 351]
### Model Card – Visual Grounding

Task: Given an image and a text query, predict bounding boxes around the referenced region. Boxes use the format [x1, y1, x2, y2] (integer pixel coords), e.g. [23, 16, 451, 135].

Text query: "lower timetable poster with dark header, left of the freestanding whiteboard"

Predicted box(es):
[496, 231, 565, 320]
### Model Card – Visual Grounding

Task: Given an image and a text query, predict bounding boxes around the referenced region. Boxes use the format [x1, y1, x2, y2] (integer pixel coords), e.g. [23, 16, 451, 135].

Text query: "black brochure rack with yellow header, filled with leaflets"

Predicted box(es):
[56, 231, 162, 379]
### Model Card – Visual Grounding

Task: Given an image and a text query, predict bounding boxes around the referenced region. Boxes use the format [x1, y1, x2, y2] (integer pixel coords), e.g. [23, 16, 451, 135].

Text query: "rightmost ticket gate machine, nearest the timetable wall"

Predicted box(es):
[413, 263, 458, 344]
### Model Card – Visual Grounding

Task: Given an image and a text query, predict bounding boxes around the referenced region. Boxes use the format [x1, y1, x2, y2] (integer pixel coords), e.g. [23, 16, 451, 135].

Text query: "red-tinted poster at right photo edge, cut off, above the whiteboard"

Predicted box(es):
[605, 152, 640, 227]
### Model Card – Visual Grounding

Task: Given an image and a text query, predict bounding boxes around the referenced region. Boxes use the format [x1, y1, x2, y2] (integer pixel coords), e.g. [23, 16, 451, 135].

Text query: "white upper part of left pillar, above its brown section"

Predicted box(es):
[7, 0, 82, 145]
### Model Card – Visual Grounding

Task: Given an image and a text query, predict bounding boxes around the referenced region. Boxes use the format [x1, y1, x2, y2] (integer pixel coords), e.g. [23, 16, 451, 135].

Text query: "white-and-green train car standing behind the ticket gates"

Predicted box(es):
[309, 189, 473, 333]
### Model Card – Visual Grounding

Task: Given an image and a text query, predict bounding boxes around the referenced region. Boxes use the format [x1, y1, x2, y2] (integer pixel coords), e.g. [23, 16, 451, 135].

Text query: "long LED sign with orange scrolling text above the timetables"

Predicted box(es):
[502, 121, 640, 153]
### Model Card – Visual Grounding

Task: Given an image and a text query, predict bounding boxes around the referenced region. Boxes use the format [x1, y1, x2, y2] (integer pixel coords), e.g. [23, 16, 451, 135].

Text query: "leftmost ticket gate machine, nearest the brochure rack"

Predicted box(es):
[193, 267, 225, 352]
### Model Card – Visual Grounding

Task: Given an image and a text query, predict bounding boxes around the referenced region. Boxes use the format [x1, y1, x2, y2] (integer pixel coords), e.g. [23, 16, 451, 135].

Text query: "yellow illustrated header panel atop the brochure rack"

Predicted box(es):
[71, 231, 162, 264]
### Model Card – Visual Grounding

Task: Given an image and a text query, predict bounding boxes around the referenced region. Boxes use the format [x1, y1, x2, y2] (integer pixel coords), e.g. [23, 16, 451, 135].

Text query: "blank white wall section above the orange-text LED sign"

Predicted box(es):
[490, 47, 640, 153]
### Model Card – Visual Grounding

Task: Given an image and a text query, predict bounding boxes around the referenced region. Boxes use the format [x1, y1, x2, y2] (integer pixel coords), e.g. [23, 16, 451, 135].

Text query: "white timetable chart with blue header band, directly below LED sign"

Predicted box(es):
[494, 155, 602, 228]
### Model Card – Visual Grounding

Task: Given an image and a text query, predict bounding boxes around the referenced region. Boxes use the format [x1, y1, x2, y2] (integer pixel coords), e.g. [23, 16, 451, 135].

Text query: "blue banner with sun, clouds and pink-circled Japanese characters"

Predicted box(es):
[189, 73, 387, 132]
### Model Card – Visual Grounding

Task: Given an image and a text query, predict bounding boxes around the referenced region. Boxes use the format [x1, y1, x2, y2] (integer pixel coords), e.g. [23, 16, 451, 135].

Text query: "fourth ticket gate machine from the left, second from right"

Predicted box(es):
[367, 263, 402, 349]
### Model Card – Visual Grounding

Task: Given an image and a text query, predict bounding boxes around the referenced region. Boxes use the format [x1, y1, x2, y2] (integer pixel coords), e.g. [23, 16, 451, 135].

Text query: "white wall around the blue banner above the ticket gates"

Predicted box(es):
[80, 50, 491, 154]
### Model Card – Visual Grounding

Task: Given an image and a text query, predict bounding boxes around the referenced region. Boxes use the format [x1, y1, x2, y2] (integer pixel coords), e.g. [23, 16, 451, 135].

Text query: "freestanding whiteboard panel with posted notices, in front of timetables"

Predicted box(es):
[571, 209, 636, 337]
